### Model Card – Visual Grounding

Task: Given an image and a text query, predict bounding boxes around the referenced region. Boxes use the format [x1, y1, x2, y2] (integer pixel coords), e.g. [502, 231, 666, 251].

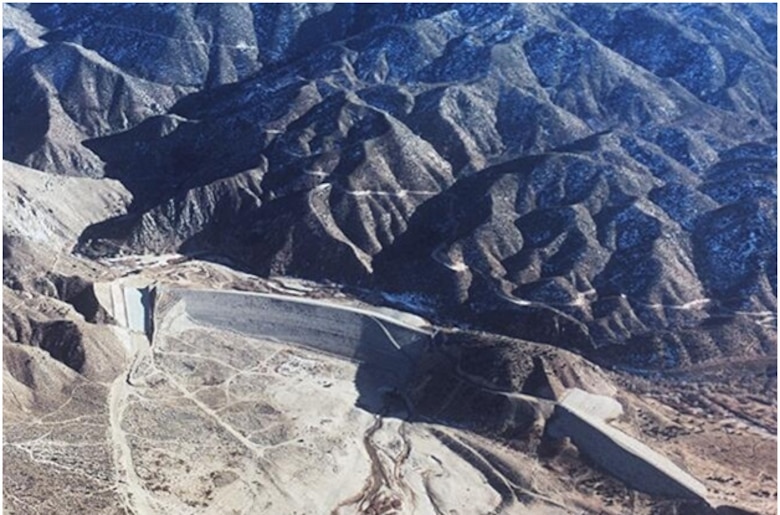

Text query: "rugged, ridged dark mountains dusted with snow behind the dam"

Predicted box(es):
[3, 4, 777, 368]
